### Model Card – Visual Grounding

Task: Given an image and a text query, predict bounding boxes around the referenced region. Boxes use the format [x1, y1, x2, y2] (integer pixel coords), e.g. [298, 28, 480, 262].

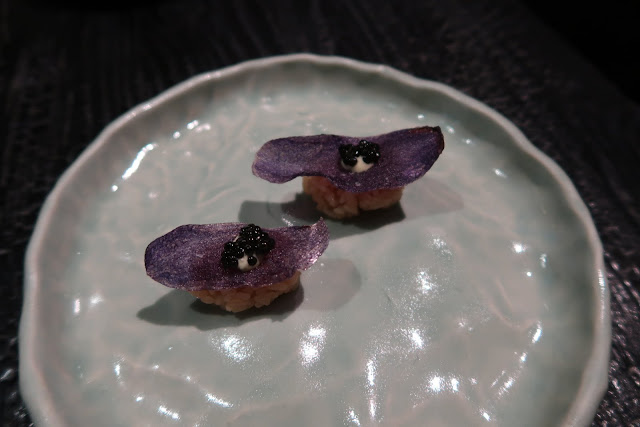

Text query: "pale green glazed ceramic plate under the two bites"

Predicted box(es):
[20, 55, 610, 426]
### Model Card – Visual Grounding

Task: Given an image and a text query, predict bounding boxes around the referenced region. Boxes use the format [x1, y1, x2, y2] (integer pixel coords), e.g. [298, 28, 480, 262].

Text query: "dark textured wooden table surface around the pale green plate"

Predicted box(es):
[0, 0, 640, 426]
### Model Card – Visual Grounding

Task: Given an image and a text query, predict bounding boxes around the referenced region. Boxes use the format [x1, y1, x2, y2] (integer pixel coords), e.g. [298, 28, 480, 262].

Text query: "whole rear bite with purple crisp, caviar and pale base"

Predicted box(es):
[252, 126, 444, 219]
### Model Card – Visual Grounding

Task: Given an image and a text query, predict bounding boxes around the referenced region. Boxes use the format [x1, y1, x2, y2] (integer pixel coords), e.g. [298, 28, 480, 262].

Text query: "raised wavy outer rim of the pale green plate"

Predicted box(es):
[18, 53, 611, 426]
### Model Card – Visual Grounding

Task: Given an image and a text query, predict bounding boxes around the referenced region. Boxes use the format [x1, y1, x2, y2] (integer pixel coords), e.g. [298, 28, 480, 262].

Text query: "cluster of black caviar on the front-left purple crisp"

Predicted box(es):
[222, 224, 276, 268]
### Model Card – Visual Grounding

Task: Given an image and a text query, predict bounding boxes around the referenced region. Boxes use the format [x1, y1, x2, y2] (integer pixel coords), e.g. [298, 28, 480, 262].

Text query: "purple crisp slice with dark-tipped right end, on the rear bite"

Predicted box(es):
[252, 126, 444, 193]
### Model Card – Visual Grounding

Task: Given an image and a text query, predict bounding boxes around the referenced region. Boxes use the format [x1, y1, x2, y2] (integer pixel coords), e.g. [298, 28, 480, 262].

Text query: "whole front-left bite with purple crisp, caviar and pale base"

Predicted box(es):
[144, 219, 329, 312]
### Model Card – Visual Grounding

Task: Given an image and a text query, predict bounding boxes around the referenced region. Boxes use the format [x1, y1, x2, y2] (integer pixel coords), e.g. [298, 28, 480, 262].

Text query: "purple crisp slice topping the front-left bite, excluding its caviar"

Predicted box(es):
[144, 219, 329, 291]
